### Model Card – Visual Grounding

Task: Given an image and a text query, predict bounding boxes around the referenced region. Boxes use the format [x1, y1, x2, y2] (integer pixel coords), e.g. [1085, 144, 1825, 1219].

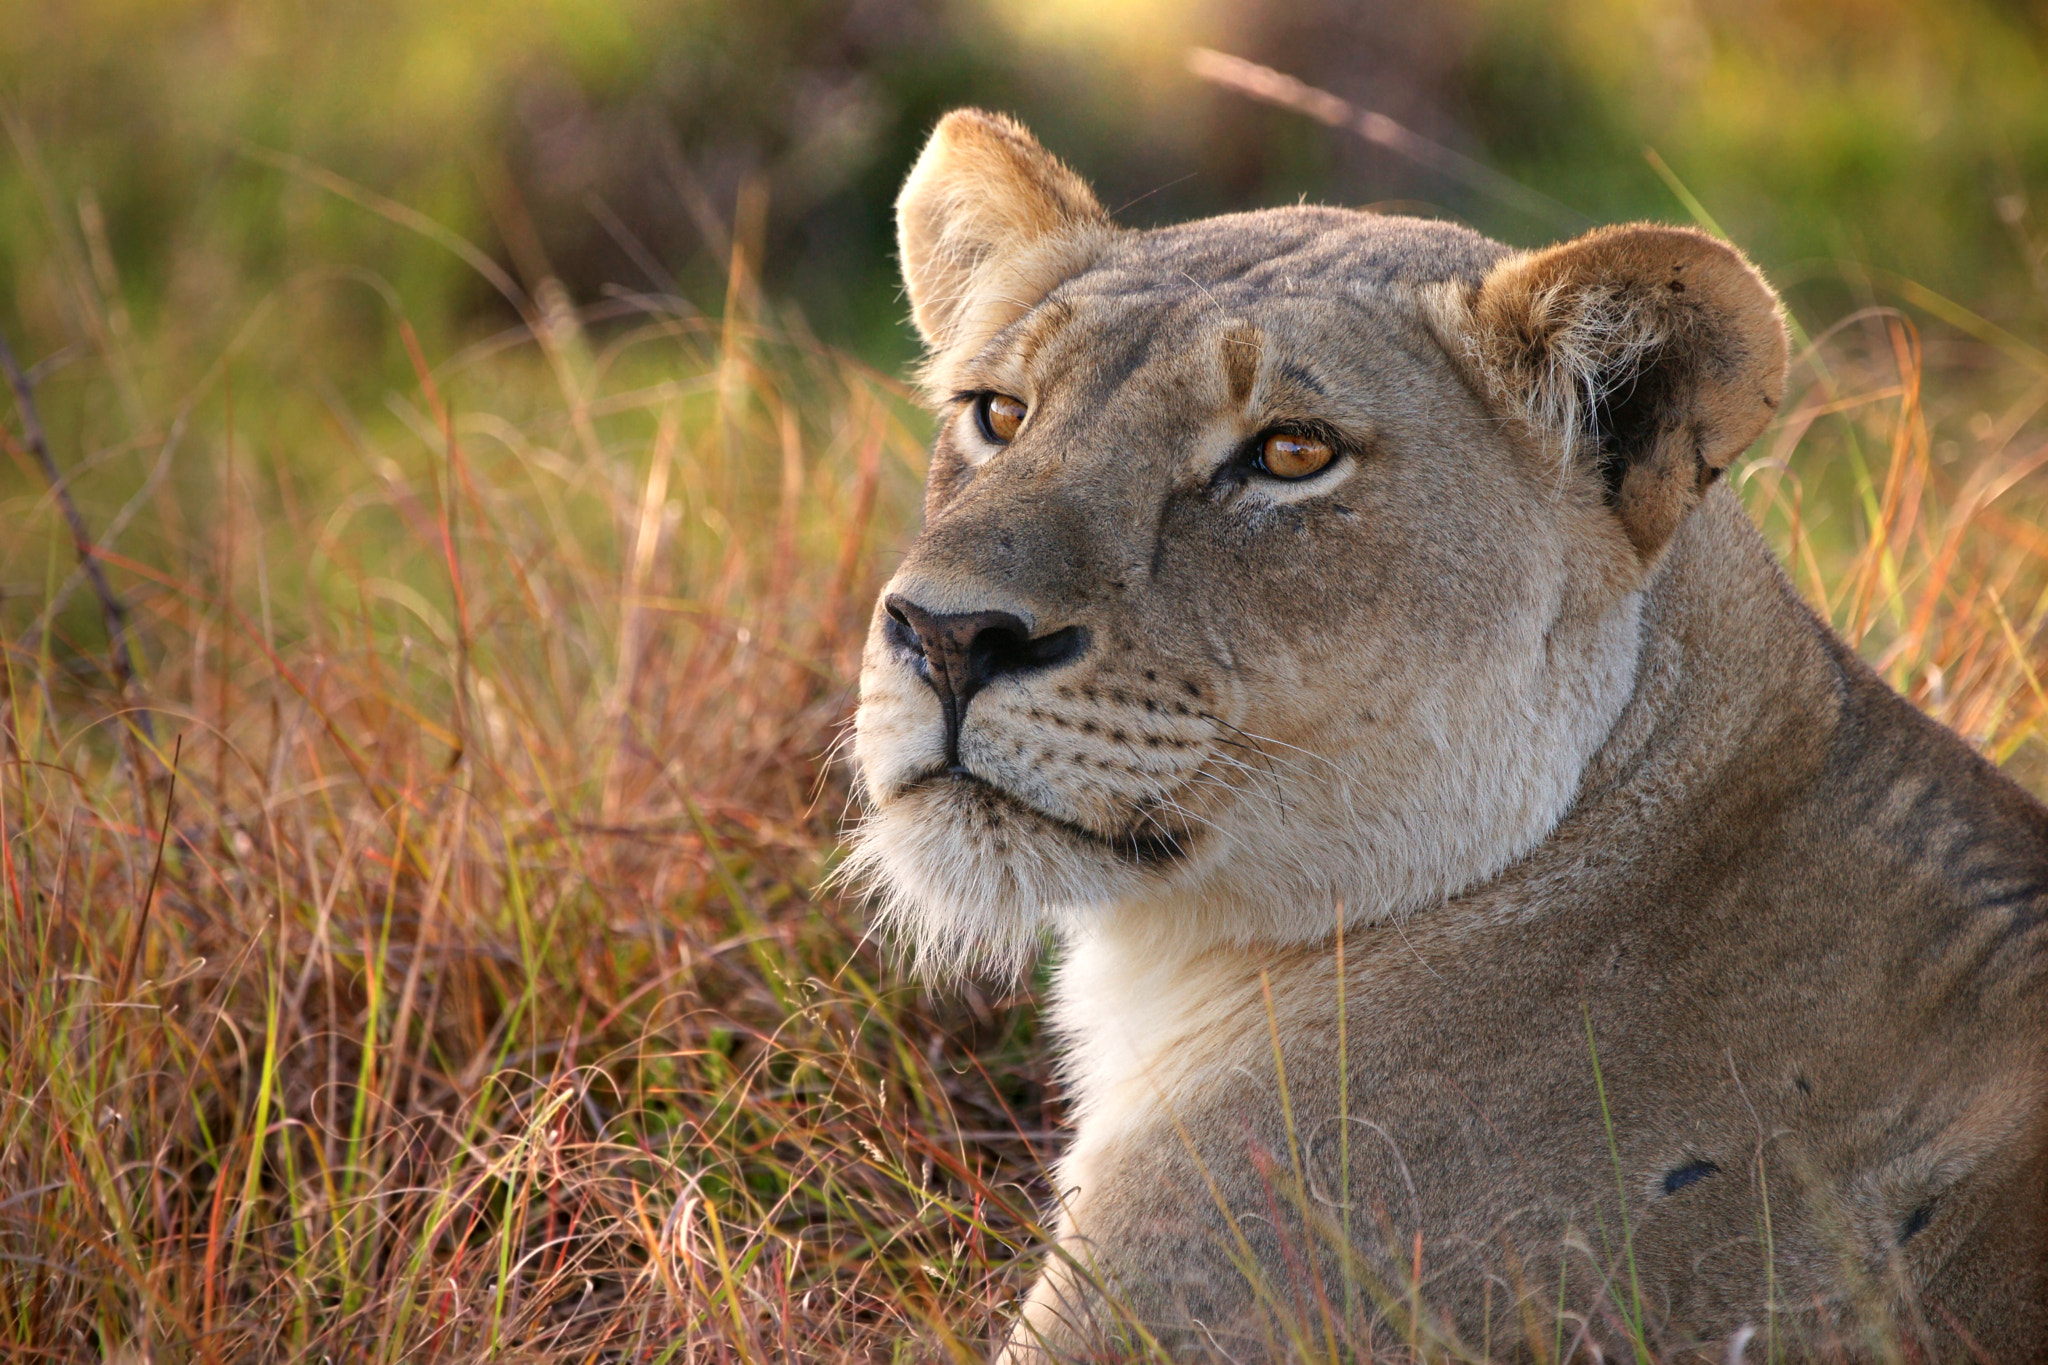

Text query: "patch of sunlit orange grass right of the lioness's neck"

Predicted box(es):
[1739, 307, 2048, 792]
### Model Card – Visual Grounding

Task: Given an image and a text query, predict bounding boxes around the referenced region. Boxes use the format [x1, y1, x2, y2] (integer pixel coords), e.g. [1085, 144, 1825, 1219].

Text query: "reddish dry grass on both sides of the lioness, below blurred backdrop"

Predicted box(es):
[0, 187, 2048, 1361]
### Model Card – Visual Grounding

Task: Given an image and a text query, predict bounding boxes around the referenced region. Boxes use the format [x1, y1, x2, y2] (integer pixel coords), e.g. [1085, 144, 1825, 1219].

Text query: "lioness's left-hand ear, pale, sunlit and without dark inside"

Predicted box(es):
[897, 108, 1112, 352]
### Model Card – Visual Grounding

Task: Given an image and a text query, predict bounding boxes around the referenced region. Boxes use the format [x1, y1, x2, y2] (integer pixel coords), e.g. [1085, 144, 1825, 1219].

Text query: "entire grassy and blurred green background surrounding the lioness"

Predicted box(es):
[0, 0, 2048, 1363]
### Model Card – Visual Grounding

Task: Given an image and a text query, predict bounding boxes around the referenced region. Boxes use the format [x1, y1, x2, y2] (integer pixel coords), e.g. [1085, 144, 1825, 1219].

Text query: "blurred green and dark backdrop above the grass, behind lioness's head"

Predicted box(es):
[12, 0, 2048, 391]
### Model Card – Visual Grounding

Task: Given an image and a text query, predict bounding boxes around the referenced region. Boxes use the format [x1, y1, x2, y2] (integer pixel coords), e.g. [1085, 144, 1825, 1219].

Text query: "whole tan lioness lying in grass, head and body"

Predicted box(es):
[854, 111, 2048, 1361]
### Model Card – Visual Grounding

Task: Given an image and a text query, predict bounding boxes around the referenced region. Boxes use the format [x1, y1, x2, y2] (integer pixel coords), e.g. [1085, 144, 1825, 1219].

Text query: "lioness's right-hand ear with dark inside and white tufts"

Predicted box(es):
[1434, 225, 1786, 561]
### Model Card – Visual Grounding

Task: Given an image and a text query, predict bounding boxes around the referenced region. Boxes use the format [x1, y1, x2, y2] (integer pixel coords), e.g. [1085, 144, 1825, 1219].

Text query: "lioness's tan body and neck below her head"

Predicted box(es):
[1034, 497, 2048, 1361]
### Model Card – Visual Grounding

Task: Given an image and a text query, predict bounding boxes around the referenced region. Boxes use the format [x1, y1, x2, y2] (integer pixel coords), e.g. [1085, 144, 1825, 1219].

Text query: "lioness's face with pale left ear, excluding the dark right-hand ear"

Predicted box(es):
[854, 115, 1777, 966]
